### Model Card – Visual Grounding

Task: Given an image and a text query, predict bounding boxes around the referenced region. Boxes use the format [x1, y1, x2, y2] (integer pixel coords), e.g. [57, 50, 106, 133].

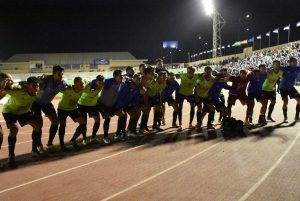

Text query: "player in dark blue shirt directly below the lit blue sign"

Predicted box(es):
[163, 73, 181, 129]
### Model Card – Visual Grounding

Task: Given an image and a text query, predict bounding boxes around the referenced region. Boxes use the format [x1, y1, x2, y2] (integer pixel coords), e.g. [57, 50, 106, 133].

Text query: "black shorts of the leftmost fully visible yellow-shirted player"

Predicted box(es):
[2, 112, 36, 127]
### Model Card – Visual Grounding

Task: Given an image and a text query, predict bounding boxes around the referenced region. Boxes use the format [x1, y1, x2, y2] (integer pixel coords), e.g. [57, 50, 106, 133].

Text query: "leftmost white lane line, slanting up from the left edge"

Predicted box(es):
[0, 145, 145, 194]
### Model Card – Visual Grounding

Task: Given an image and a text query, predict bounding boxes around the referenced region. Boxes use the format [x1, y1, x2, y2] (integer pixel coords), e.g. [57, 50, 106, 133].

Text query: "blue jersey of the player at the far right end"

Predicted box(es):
[279, 66, 300, 90]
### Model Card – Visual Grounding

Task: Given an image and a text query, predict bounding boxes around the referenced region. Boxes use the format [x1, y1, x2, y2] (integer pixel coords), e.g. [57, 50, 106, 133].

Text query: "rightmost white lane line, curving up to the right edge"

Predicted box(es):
[239, 131, 300, 201]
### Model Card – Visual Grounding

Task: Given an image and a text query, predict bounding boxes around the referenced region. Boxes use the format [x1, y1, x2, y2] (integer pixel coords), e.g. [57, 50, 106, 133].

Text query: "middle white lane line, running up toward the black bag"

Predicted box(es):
[101, 142, 221, 201]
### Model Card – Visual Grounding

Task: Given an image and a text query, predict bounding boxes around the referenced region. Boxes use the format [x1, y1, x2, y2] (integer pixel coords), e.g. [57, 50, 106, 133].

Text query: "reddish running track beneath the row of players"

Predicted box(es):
[0, 96, 300, 201]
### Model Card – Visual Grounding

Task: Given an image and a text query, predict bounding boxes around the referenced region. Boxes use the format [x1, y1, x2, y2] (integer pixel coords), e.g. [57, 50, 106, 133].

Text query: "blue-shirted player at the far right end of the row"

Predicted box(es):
[279, 57, 300, 122]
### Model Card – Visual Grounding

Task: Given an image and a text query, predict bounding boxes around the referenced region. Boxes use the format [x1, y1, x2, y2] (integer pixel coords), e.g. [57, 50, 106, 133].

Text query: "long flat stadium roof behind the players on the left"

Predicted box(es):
[5, 52, 137, 64]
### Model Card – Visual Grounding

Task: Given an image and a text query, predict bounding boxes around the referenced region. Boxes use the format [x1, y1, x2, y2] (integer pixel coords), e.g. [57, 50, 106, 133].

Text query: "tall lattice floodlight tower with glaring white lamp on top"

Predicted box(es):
[202, 0, 225, 58]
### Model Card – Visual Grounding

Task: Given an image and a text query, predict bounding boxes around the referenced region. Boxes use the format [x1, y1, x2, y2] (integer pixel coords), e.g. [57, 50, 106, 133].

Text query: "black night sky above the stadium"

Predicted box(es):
[0, 0, 300, 61]
